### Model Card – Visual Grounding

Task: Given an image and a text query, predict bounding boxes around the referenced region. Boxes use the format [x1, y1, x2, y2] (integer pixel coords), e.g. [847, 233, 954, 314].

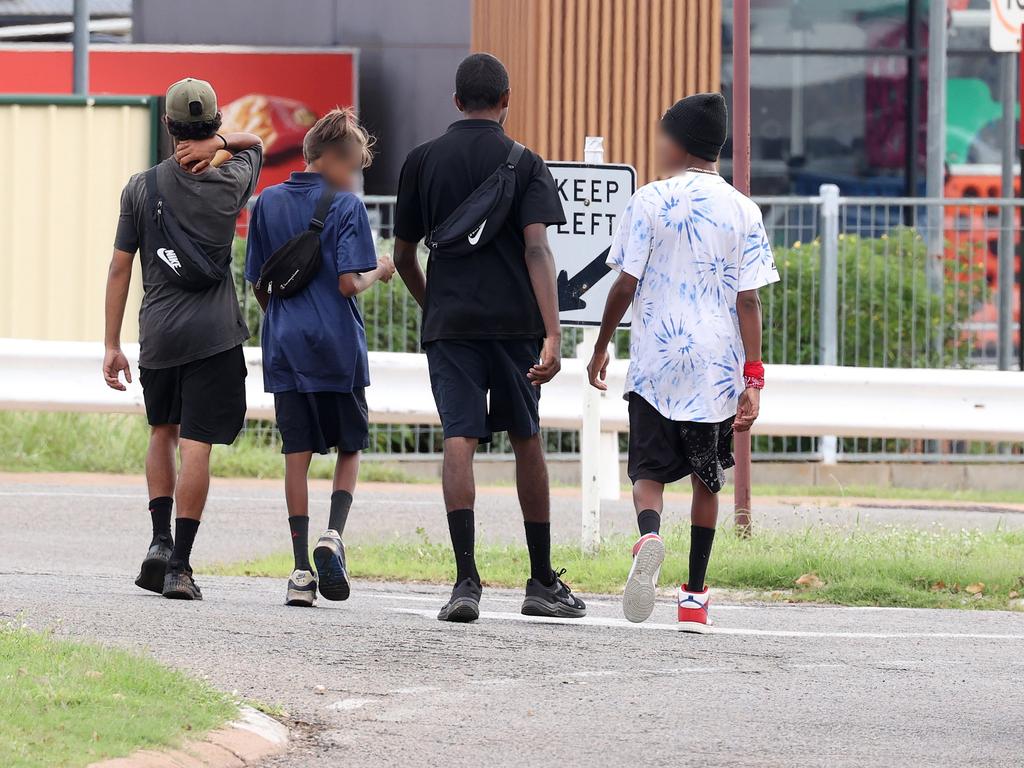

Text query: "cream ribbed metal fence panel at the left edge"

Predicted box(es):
[0, 103, 153, 342]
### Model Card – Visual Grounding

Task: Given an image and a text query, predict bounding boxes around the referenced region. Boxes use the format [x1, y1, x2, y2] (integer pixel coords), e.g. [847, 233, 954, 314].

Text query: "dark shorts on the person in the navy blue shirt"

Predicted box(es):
[273, 387, 370, 454]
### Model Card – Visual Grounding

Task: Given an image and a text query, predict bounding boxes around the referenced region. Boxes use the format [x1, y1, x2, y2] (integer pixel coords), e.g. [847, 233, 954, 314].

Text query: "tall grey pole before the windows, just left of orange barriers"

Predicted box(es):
[926, 0, 947, 303]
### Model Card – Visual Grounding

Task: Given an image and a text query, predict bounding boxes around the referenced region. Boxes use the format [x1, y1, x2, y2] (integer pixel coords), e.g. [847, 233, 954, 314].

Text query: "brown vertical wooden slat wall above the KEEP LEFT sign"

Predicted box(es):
[472, 0, 722, 183]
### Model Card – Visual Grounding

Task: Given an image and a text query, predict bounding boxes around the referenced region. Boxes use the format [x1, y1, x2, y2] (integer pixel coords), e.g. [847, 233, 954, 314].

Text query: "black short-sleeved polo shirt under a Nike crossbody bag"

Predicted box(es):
[394, 120, 565, 344]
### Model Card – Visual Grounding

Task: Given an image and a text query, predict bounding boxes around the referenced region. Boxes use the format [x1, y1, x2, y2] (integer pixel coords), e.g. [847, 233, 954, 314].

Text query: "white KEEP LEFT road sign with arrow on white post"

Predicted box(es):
[548, 136, 636, 552]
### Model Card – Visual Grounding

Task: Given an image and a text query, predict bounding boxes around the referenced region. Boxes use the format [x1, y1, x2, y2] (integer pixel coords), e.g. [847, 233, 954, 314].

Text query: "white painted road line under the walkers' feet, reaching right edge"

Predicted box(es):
[391, 608, 1024, 641]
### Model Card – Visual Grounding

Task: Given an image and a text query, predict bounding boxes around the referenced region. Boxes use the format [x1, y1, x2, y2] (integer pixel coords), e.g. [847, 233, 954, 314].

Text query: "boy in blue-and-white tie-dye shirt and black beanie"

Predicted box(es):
[588, 93, 778, 632]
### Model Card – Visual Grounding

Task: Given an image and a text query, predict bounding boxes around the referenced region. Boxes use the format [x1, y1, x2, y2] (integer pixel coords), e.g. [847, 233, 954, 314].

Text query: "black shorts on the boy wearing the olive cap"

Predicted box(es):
[138, 345, 246, 445]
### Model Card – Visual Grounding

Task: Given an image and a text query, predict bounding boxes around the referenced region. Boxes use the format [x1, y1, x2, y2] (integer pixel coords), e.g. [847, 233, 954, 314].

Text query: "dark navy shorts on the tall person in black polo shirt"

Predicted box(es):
[426, 339, 541, 442]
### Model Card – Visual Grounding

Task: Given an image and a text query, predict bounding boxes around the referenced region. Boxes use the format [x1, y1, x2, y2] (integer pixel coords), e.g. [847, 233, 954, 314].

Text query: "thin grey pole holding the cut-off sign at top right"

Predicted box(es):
[997, 53, 1017, 371]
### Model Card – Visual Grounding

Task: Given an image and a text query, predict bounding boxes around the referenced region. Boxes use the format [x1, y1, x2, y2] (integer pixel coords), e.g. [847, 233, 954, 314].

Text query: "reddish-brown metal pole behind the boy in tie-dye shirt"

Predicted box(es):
[732, 0, 751, 534]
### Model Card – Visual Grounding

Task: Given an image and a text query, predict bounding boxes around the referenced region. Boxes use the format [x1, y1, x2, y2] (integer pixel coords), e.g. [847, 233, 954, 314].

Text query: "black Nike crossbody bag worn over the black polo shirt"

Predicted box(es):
[427, 141, 525, 258]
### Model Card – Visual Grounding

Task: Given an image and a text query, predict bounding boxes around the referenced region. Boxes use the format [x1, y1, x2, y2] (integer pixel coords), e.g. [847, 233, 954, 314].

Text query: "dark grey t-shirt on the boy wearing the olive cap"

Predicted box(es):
[114, 146, 263, 369]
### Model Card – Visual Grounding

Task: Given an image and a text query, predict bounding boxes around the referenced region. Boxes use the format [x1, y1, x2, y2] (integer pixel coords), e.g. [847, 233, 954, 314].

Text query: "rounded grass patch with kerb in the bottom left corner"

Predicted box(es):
[0, 626, 238, 768]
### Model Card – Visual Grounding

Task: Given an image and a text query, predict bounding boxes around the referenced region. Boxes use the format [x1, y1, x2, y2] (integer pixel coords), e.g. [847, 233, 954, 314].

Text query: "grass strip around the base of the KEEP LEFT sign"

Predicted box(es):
[208, 526, 1024, 609]
